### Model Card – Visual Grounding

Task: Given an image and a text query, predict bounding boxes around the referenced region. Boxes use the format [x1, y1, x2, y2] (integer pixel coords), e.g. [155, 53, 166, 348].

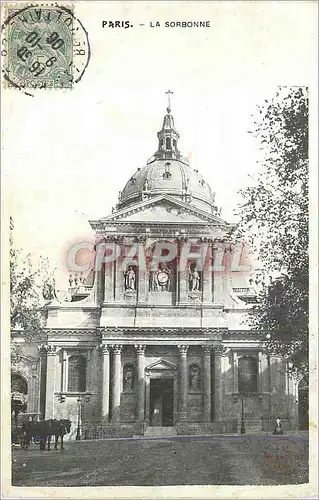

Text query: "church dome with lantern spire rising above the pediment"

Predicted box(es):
[116, 101, 217, 214]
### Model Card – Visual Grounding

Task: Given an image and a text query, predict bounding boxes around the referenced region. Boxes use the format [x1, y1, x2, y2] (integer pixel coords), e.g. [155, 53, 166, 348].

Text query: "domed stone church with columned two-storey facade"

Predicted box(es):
[10, 97, 304, 439]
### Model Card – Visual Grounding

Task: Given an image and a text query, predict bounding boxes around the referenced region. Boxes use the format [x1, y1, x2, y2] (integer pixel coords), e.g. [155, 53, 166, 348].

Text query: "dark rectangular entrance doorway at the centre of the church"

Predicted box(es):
[150, 378, 174, 427]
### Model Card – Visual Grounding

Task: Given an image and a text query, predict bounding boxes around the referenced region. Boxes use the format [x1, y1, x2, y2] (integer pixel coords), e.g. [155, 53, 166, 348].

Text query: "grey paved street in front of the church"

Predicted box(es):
[12, 435, 308, 486]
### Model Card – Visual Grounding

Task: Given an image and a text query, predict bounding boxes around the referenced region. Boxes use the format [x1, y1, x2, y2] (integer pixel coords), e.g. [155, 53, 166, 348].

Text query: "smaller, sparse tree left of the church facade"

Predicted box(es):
[10, 232, 54, 340]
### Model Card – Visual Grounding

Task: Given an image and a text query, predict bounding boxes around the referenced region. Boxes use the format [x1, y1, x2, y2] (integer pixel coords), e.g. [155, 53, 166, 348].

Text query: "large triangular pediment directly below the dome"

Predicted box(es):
[94, 195, 227, 226]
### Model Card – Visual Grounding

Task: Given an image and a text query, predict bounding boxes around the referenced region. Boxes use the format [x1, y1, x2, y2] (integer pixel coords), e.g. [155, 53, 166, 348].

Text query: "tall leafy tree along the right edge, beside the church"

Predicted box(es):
[237, 87, 309, 374]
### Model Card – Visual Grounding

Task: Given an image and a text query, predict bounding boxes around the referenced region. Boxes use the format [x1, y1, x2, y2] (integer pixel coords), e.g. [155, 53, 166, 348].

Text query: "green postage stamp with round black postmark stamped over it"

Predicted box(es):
[1, 4, 90, 89]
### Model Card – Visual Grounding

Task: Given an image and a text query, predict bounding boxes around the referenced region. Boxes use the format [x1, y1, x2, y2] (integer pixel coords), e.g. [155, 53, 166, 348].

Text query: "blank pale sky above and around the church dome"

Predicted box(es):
[2, 2, 317, 286]
